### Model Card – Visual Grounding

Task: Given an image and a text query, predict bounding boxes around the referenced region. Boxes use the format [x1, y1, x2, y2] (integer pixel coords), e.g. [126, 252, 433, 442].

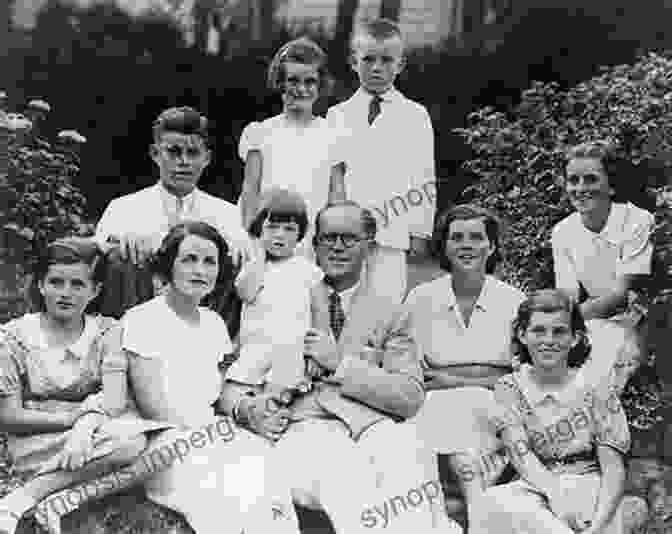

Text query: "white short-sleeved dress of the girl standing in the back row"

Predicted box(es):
[238, 114, 344, 258]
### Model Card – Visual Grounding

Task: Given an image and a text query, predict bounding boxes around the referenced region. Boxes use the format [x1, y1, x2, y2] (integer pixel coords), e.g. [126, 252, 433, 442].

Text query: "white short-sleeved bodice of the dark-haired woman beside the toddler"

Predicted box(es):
[122, 296, 233, 426]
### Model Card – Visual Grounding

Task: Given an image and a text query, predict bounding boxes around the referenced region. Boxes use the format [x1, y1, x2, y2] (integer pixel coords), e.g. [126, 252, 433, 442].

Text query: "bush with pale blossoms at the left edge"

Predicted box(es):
[0, 100, 91, 320]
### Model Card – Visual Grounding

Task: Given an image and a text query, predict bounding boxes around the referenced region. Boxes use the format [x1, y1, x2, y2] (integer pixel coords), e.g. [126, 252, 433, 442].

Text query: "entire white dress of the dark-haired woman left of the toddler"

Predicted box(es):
[123, 296, 298, 534]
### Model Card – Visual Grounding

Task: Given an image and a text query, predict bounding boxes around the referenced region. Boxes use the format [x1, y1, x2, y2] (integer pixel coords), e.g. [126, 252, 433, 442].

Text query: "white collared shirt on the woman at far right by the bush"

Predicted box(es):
[551, 202, 654, 297]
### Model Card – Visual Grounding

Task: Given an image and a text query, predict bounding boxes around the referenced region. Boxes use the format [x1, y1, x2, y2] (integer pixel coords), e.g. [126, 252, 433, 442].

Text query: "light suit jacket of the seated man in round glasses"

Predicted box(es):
[294, 282, 425, 439]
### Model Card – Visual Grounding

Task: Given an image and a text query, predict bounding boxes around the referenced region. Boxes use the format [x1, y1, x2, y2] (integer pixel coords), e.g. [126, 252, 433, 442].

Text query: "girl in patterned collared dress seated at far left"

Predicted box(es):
[0, 238, 157, 534]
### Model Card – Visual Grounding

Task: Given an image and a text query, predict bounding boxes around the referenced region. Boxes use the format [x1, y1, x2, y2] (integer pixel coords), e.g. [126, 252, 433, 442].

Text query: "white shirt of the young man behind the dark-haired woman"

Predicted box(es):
[95, 182, 249, 258]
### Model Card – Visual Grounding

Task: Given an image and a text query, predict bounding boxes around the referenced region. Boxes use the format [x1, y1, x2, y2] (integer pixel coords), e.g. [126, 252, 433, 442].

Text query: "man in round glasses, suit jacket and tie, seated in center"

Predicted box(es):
[218, 201, 461, 534]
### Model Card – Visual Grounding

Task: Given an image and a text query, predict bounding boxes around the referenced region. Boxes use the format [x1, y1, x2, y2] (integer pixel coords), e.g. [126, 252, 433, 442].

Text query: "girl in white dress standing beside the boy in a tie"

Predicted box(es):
[239, 37, 345, 255]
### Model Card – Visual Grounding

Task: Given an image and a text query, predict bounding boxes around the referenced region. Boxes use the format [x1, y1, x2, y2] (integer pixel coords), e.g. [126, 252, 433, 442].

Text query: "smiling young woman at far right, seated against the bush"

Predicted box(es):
[552, 141, 653, 391]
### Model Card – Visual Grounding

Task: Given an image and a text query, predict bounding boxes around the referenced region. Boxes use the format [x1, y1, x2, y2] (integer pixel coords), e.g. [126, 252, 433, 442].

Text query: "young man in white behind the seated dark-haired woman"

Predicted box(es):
[95, 107, 249, 317]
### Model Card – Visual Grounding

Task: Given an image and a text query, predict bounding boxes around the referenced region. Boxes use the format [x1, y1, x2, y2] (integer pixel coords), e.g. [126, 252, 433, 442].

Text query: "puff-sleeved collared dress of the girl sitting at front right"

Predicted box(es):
[469, 364, 630, 534]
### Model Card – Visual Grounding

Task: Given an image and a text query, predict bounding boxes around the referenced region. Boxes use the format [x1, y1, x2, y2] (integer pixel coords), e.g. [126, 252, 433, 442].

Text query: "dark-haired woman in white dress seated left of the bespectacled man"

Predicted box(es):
[45, 222, 298, 534]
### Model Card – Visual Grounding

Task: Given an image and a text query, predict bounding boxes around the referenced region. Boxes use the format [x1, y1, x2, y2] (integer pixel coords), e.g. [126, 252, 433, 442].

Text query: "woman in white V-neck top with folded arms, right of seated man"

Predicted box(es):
[406, 205, 525, 504]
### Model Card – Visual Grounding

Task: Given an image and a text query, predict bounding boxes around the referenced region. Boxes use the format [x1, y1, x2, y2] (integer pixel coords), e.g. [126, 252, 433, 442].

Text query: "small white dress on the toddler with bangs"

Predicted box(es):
[226, 255, 324, 388]
